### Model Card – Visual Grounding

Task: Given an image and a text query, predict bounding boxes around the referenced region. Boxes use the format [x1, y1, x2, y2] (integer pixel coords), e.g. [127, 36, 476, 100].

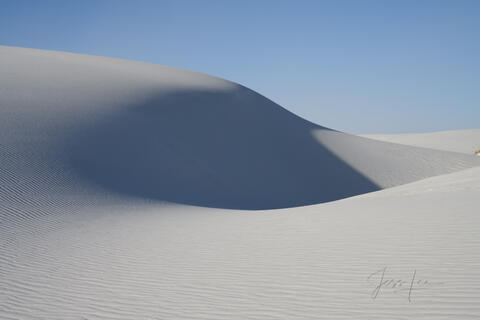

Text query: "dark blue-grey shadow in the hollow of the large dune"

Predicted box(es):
[67, 86, 379, 210]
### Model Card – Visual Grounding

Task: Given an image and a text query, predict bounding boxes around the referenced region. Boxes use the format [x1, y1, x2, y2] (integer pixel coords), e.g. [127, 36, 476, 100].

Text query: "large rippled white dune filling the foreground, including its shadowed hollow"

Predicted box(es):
[0, 47, 480, 319]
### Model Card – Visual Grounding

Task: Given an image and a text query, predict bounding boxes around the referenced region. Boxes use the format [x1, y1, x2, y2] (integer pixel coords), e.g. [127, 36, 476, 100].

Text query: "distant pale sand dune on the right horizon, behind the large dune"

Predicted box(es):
[362, 129, 480, 154]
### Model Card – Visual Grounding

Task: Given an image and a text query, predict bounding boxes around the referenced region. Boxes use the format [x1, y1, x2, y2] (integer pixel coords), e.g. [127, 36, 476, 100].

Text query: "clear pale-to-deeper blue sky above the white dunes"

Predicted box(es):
[0, 0, 480, 133]
